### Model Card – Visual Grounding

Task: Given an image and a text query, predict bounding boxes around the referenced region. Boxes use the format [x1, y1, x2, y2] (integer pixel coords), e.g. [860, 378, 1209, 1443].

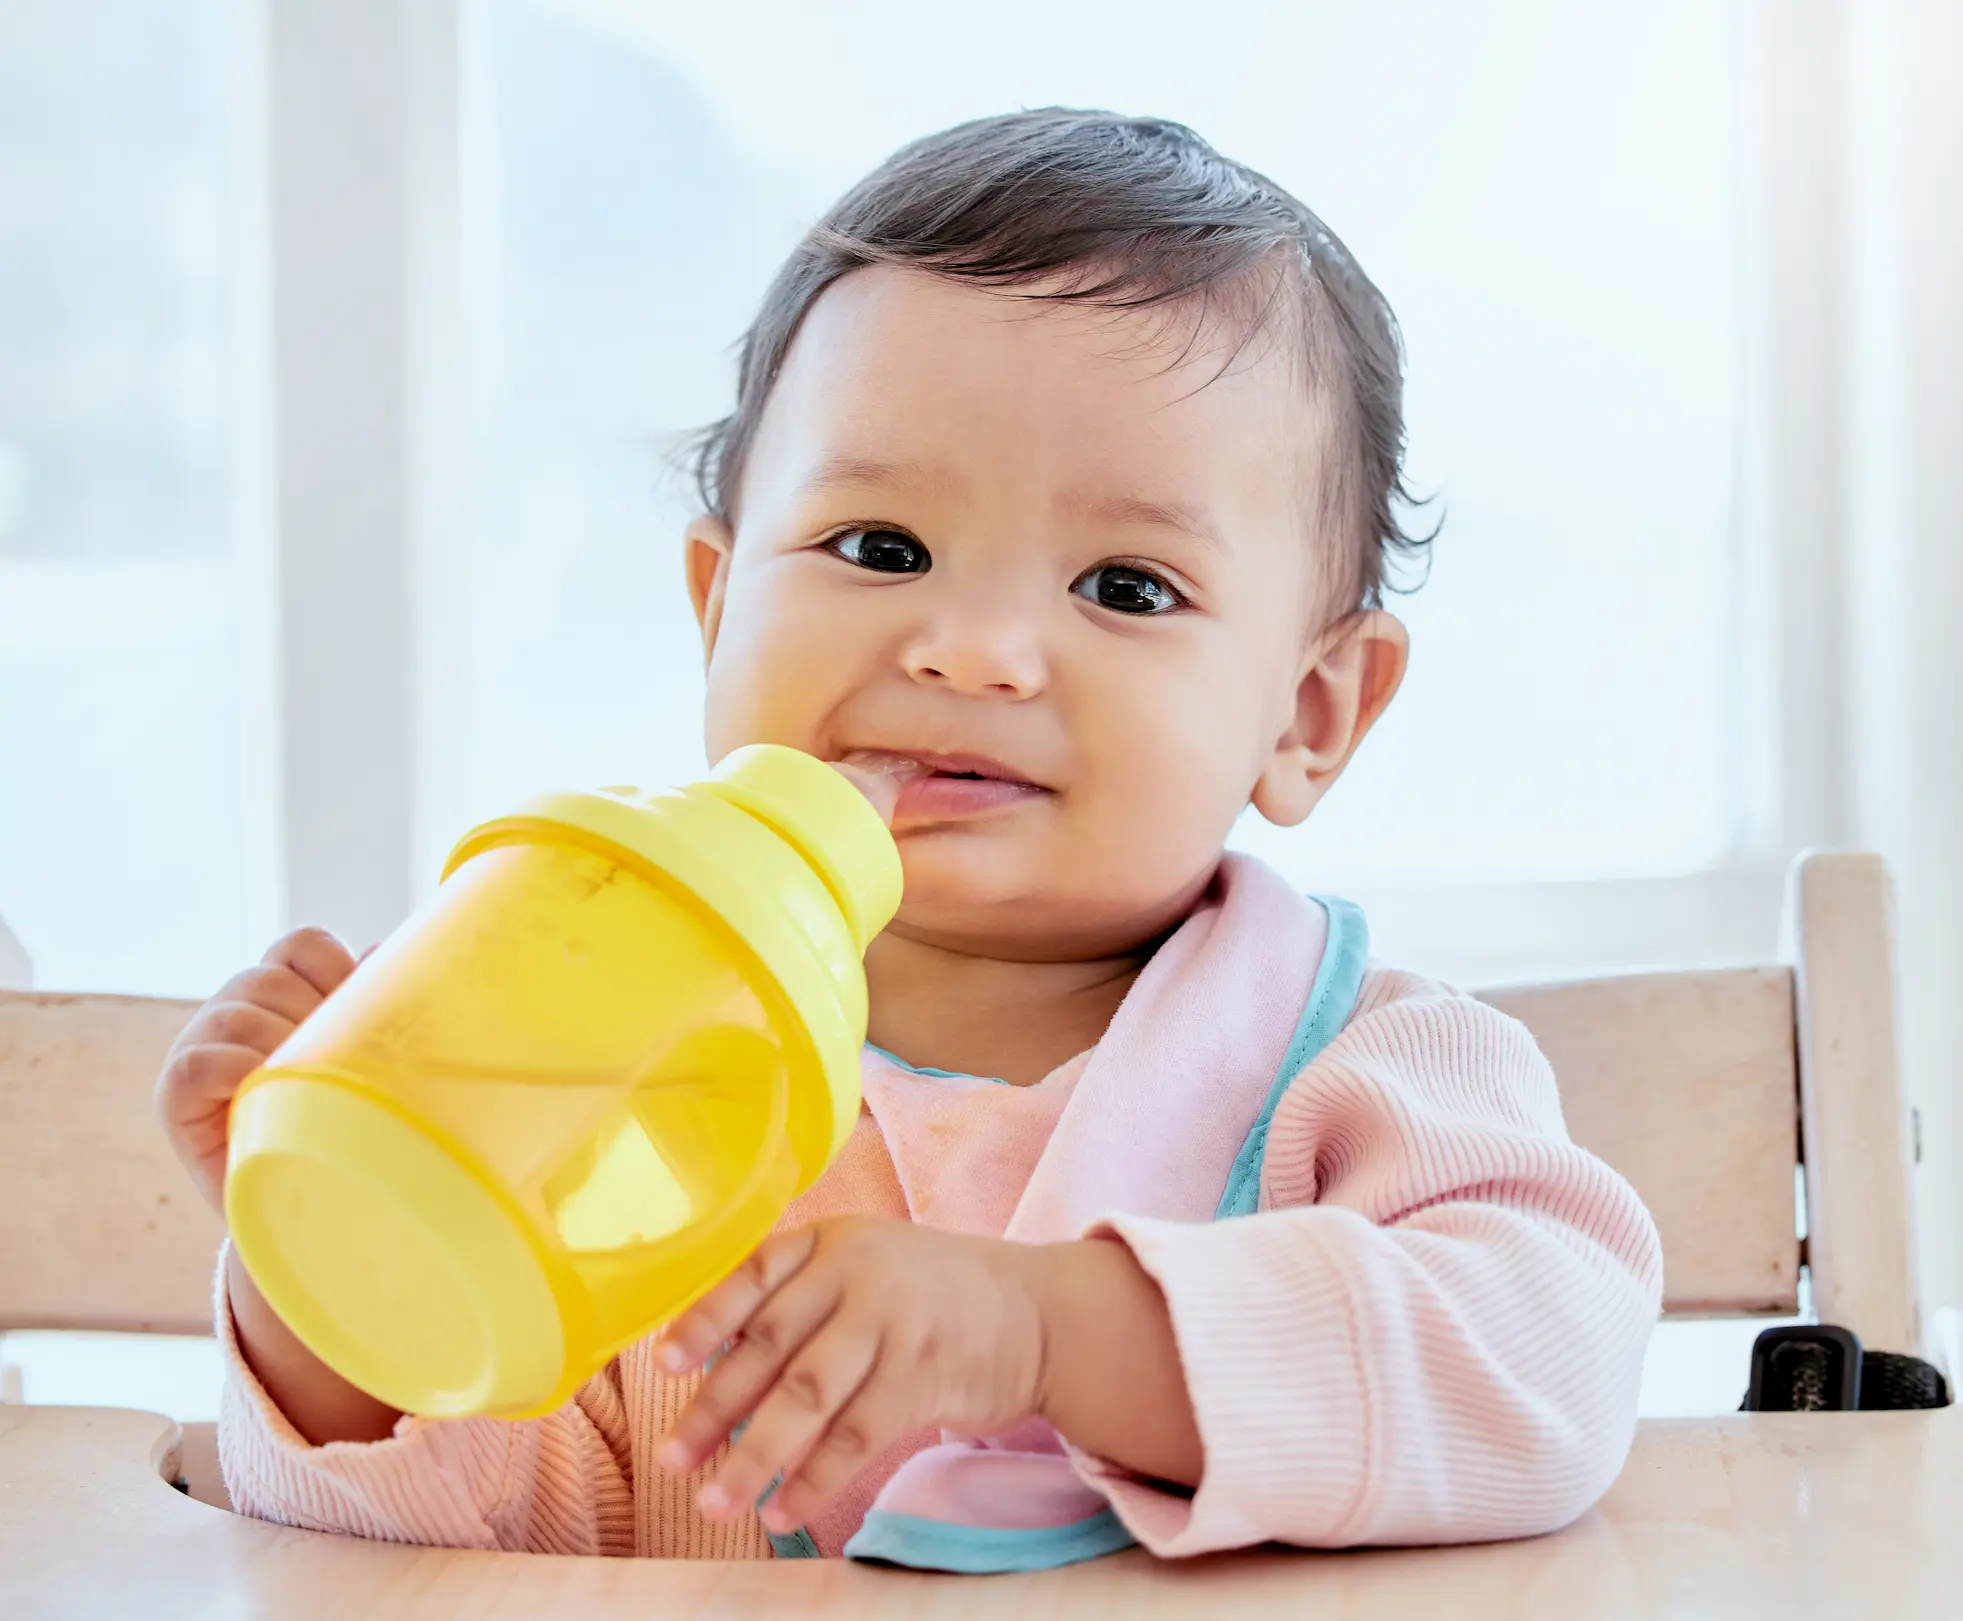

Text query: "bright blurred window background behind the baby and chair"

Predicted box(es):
[0, 0, 1963, 1417]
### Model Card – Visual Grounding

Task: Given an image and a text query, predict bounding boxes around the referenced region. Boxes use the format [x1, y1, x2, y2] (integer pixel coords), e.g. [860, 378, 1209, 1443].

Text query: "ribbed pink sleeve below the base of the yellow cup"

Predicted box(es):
[218, 1258, 634, 1554]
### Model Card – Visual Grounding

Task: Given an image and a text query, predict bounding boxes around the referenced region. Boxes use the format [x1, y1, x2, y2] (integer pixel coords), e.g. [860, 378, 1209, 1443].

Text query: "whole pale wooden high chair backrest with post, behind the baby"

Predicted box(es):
[0, 854, 1920, 1352]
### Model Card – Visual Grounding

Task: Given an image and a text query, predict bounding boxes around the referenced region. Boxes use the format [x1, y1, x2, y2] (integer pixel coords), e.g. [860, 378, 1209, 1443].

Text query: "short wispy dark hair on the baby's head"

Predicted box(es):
[693, 108, 1429, 610]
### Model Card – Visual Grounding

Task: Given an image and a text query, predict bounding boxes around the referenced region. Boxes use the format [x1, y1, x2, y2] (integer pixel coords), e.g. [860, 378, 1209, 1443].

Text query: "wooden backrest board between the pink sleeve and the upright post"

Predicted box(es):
[1480, 967, 1800, 1317]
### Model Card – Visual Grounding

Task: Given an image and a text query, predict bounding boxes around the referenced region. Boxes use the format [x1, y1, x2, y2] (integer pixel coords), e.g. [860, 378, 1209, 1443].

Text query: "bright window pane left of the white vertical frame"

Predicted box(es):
[0, 0, 277, 993]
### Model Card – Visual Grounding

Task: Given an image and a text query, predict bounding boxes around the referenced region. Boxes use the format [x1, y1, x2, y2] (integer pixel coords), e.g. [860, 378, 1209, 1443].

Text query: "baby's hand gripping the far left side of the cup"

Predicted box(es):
[157, 928, 355, 1215]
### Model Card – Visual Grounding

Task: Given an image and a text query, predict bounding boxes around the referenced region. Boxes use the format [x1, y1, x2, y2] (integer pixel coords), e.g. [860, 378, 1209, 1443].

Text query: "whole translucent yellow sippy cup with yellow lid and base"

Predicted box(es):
[226, 746, 899, 1417]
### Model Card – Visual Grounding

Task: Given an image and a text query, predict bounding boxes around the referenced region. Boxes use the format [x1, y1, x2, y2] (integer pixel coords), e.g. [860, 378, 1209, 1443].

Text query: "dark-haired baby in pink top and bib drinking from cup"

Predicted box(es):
[159, 110, 1661, 1570]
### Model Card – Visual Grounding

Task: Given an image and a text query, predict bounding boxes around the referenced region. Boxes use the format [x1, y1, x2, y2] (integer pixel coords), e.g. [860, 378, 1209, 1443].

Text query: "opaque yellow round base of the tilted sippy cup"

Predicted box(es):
[226, 1075, 565, 1417]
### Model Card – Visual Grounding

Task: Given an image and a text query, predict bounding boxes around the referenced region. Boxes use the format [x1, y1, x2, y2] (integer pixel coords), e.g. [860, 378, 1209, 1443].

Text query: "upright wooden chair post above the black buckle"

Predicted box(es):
[1786, 852, 1922, 1352]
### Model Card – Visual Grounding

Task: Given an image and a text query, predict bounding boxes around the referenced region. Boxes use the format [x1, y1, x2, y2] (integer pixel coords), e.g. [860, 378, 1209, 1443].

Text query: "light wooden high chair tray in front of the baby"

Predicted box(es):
[0, 1407, 1963, 1621]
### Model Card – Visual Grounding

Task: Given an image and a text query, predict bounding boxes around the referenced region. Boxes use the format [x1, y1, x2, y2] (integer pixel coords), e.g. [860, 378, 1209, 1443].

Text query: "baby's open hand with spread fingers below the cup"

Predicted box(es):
[660, 1217, 1044, 1531]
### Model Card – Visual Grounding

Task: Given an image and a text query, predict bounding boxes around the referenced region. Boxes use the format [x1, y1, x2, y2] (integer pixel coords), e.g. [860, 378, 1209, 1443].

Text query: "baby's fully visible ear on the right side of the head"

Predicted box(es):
[1252, 608, 1411, 828]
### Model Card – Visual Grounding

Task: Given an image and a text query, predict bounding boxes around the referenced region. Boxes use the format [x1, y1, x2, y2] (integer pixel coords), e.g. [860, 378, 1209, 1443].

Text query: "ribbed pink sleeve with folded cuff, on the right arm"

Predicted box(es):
[1080, 971, 1663, 1556]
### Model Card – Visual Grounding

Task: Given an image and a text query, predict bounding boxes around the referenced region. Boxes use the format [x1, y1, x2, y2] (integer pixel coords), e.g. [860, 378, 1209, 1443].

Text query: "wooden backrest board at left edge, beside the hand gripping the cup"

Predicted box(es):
[0, 991, 220, 1334]
